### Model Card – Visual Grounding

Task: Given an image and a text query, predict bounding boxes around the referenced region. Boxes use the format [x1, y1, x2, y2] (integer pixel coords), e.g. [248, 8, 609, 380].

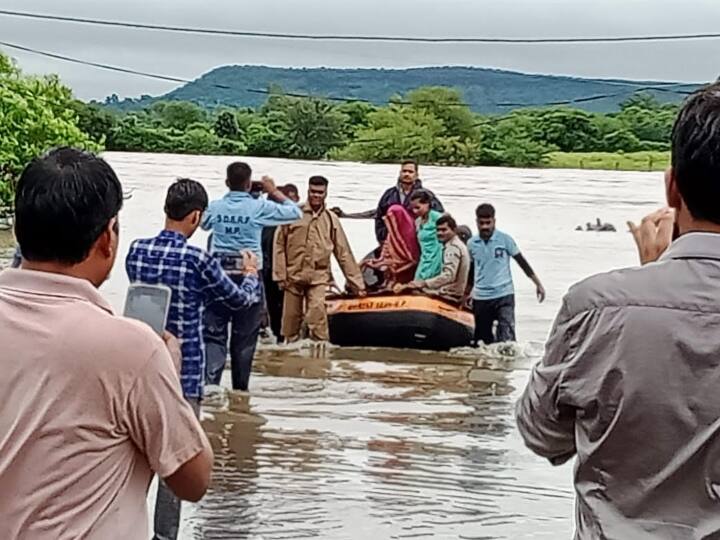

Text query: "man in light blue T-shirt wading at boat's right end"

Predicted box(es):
[468, 204, 545, 345]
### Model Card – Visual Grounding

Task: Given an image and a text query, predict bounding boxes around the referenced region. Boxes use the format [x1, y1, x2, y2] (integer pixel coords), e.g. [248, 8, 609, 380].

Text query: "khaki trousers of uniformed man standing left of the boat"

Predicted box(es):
[282, 283, 330, 341]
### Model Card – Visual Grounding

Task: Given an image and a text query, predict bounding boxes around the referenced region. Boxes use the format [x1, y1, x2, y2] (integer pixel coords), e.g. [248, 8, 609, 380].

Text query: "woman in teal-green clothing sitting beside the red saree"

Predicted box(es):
[410, 189, 443, 281]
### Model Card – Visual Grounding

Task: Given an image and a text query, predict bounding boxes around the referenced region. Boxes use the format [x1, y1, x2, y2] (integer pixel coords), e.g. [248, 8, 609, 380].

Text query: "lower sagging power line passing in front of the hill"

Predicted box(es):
[0, 41, 692, 115]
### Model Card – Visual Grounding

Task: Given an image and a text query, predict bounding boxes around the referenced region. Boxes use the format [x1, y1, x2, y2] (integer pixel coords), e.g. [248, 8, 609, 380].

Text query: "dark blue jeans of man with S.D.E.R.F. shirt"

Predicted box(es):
[203, 274, 265, 391]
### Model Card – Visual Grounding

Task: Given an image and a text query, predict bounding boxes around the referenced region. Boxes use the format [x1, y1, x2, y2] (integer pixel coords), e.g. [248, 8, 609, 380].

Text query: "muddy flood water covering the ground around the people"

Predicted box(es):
[32, 154, 663, 540]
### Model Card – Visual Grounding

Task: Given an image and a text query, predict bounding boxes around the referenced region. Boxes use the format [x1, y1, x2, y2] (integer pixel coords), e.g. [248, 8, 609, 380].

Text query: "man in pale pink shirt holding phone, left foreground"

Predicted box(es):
[0, 148, 212, 540]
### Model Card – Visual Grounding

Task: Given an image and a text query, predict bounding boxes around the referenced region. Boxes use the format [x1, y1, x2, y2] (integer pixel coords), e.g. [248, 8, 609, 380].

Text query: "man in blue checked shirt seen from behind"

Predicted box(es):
[125, 179, 260, 540]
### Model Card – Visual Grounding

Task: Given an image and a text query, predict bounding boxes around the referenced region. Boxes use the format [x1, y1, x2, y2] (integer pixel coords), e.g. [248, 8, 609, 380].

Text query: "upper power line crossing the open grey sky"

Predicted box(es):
[0, 9, 720, 44]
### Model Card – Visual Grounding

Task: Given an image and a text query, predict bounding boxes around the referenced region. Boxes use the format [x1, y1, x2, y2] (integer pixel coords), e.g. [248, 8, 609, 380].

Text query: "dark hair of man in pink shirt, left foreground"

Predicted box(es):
[15, 147, 123, 265]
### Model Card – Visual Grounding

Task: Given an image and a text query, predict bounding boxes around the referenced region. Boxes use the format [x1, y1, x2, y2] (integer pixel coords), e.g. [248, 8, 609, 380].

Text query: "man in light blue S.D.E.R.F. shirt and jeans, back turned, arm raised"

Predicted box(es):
[202, 162, 302, 390]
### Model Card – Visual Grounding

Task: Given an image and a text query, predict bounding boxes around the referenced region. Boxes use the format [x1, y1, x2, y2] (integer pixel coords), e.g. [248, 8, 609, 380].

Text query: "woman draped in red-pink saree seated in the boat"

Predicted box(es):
[363, 204, 420, 289]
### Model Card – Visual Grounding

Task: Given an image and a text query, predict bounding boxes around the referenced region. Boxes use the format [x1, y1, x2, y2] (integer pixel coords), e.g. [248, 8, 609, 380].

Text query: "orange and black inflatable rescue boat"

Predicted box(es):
[327, 295, 475, 351]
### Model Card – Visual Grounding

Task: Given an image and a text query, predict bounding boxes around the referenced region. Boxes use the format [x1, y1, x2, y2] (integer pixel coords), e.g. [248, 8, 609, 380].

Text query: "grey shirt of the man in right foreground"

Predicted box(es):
[517, 233, 720, 540]
